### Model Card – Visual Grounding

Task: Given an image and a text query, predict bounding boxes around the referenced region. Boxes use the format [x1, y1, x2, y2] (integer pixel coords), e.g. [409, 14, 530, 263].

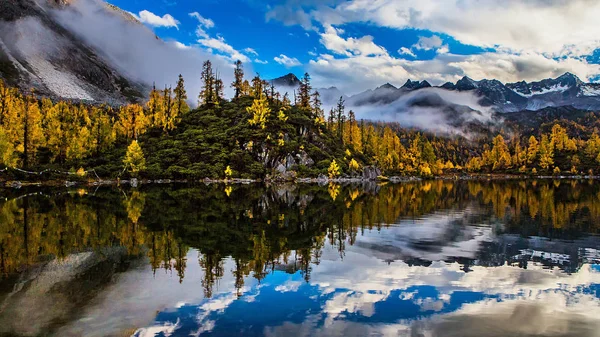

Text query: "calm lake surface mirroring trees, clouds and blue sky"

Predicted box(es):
[0, 180, 600, 337]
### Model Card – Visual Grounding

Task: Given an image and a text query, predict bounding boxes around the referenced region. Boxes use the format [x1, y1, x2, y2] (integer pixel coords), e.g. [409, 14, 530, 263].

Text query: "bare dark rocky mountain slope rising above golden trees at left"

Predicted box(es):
[0, 0, 145, 104]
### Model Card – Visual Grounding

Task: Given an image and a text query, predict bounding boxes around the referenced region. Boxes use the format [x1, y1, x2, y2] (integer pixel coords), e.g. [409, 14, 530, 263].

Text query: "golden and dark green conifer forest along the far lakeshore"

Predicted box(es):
[0, 61, 600, 180]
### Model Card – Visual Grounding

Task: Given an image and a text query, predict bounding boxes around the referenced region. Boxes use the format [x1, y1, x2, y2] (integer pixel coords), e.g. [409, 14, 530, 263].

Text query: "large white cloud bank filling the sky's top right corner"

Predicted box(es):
[298, 0, 600, 56]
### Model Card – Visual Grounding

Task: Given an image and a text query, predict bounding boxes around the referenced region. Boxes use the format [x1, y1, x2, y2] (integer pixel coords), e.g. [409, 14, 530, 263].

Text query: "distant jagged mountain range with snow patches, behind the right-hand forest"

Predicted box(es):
[274, 73, 600, 112]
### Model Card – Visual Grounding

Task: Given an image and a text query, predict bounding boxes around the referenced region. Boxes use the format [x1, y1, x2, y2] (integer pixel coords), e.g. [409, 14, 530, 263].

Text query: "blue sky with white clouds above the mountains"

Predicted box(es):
[109, 0, 600, 92]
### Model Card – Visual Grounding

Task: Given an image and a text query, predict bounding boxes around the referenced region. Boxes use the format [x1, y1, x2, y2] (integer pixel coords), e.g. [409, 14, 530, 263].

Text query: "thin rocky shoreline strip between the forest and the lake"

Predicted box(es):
[0, 174, 600, 189]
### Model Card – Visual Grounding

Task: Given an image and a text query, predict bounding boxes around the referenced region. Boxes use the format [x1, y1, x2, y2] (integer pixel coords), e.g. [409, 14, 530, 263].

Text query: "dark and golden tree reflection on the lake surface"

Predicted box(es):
[0, 180, 600, 297]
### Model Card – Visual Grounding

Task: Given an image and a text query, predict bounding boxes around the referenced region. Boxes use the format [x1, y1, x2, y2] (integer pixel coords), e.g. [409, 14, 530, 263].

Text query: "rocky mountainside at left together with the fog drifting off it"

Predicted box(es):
[0, 0, 239, 103]
